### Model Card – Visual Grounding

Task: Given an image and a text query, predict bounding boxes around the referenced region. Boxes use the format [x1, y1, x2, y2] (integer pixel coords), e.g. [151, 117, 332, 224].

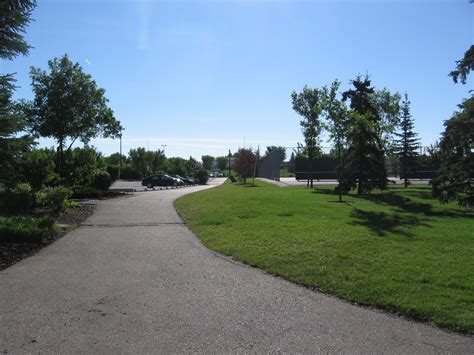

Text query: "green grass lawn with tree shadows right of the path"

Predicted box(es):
[176, 182, 474, 333]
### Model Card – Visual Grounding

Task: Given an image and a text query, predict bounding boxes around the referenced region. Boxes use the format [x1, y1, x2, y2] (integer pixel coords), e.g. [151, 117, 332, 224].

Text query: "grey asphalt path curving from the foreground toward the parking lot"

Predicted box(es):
[0, 179, 474, 354]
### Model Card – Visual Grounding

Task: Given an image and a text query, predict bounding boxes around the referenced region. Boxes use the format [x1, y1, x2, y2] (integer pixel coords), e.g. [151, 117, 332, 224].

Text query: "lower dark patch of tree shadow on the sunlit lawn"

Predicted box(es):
[351, 208, 430, 238]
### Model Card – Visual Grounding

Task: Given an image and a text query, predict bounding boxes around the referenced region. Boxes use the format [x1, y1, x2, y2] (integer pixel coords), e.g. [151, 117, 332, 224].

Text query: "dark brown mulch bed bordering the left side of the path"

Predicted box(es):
[0, 204, 96, 270]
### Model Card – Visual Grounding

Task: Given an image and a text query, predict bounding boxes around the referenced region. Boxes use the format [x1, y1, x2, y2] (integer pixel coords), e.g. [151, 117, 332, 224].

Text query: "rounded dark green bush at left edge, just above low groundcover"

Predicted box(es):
[0, 184, 34, 216]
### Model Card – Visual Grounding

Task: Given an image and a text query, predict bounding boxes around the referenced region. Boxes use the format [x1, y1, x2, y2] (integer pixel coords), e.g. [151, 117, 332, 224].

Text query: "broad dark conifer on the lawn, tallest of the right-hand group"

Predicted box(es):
[340, 76, 387, 194]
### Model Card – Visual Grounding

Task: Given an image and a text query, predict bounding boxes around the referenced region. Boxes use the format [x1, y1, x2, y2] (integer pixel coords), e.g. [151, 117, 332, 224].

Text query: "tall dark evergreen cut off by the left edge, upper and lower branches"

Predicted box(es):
[0, 0, 36, 187]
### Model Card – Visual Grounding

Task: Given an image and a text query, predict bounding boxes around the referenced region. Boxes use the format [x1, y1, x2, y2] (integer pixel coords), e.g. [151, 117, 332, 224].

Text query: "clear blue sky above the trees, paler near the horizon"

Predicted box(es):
[0, 0, 474, 159]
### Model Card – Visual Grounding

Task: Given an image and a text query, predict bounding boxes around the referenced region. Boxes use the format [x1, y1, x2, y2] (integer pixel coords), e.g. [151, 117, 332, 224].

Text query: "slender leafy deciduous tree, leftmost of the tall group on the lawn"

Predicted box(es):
[291, 86, 324, 188]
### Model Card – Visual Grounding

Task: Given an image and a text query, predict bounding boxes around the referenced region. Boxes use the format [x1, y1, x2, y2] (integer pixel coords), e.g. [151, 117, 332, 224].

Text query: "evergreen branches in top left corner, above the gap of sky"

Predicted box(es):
[0, 0, 36, 60]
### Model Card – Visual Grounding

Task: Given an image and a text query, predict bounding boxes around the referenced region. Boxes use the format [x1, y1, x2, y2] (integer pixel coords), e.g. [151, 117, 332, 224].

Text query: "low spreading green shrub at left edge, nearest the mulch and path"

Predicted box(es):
[0, 217, 58, 244]
